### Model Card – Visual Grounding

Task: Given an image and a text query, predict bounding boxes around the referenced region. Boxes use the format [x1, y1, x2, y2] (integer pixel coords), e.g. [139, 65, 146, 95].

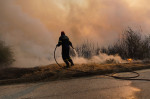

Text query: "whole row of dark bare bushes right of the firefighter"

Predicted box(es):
[71, 27, 150, 60]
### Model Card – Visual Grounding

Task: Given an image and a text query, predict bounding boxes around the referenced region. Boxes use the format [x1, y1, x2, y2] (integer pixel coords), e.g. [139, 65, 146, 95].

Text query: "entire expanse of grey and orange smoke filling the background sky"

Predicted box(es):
[0, 0, 150, 67]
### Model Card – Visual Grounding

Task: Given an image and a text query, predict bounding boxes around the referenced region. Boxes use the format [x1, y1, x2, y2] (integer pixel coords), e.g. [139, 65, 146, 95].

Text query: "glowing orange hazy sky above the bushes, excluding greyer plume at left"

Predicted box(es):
[14, 0, 150, 43]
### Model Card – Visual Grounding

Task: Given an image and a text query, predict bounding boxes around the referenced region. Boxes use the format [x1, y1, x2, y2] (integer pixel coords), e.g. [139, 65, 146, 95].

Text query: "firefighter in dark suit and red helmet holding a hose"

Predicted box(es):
[56, 31, 74, 68]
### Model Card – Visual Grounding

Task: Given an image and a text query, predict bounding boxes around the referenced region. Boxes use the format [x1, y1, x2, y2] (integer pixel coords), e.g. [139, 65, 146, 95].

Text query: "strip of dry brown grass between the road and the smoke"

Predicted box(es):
[0, 63, 150, 84]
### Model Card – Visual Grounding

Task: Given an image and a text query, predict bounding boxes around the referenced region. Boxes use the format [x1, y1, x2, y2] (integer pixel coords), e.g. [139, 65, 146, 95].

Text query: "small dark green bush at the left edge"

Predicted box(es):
[0, 41, 14, 66]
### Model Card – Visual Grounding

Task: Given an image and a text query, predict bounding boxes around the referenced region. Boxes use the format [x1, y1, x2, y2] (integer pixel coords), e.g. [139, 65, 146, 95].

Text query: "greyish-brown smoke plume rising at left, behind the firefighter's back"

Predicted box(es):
[0, 0, 53, 66]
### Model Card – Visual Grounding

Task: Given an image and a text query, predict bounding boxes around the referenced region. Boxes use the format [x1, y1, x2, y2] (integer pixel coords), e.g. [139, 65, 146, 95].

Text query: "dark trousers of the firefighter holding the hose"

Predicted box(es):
[62, 47, 74, 67]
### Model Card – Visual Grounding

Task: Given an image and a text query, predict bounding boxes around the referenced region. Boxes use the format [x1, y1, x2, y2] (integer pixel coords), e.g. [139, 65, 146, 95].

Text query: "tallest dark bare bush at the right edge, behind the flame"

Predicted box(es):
[106, 28, 150, 59]
